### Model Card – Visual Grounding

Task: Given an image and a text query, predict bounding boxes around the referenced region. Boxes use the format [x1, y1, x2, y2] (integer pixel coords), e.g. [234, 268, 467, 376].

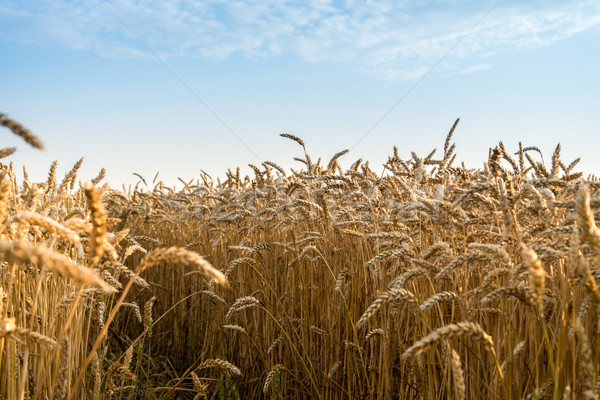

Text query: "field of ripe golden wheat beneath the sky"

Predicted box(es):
[0, 114, 600, 399]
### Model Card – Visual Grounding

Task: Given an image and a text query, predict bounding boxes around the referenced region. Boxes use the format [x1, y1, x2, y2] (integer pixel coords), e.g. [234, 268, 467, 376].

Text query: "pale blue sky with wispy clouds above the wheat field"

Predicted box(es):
[0, 0, 600, 185]
